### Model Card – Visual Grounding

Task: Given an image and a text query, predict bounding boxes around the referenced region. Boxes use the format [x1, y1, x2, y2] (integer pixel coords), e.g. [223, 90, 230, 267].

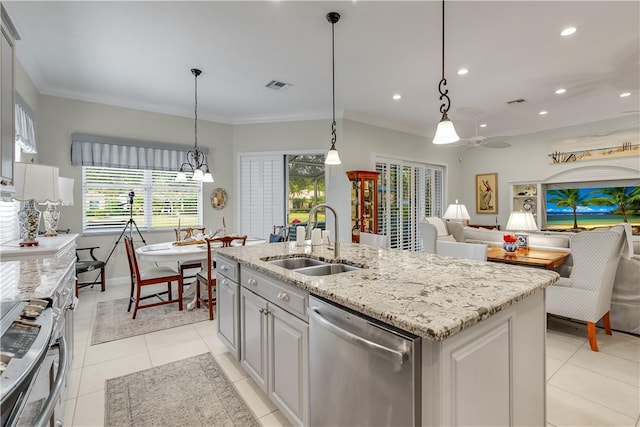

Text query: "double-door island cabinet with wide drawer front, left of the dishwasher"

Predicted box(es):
[240, 266, 309, 425]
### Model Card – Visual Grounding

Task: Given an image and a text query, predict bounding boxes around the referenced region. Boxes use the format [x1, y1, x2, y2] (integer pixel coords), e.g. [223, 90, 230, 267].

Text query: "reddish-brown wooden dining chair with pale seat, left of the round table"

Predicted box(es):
[124, 236, 183, 319]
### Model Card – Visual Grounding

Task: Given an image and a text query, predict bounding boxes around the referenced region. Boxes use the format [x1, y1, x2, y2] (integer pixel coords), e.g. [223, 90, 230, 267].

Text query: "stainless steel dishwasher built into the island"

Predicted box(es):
[308, 296, 422, 427]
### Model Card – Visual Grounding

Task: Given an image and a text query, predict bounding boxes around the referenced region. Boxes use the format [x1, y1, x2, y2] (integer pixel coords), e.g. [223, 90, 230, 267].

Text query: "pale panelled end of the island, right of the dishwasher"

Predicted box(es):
[422, 292, 546, 426]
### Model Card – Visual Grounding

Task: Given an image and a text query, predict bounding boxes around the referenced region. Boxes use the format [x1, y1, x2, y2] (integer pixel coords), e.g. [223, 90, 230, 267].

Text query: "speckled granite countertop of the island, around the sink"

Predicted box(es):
[218, 242, 559, 341]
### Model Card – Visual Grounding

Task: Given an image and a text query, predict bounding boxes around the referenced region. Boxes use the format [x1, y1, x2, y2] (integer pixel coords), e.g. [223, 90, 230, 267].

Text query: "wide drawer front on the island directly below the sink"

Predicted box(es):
[241, 266, 309, 320]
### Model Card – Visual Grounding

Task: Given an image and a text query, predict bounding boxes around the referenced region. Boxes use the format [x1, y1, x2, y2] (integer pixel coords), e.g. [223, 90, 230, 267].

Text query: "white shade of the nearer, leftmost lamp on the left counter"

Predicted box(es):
[13, 163, 60, 203]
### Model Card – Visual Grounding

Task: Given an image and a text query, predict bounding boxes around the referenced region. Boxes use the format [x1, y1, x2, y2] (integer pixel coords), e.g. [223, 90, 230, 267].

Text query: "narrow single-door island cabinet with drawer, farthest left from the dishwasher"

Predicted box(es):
[216, 256, 241, 359]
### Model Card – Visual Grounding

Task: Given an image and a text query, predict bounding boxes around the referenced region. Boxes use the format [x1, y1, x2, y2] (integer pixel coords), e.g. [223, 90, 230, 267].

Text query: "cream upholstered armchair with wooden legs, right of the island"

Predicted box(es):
[546, 226, 625, 351]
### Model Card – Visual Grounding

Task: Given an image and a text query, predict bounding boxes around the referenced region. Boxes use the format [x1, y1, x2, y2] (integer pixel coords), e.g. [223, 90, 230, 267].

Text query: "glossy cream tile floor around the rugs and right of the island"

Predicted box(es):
[64, 286, 640, 427]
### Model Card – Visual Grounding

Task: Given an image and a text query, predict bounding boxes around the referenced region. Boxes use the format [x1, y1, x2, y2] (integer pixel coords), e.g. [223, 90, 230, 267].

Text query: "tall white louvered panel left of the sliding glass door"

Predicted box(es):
[239, 154, 285, 239]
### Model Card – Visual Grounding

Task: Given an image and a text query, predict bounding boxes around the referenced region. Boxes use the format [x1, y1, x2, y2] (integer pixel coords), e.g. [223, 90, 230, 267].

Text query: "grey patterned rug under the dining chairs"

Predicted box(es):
[91, 297, 209, 345]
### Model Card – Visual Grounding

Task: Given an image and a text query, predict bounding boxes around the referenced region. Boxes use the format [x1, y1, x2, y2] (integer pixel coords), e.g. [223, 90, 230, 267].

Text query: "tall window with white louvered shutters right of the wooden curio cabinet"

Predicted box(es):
[376, 158, 444, 250]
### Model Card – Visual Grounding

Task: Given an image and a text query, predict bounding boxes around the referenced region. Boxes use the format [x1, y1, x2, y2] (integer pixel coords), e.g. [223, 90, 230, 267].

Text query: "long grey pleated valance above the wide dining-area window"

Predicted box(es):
[71, 133, 209, 171]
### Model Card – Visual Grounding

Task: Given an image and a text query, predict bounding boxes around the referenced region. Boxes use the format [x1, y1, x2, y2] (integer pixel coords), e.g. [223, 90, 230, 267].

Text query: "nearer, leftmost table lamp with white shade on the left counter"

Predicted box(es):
[13, 163, 60, 246]
